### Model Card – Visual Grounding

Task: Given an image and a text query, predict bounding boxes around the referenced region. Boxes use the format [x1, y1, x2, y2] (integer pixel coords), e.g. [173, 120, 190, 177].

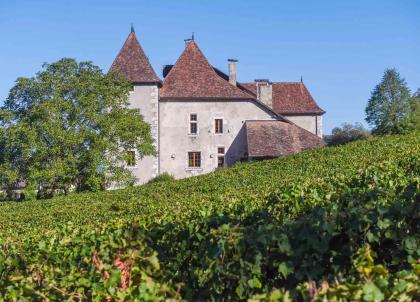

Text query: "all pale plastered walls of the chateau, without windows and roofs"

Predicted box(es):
[124, 85, 322, 184]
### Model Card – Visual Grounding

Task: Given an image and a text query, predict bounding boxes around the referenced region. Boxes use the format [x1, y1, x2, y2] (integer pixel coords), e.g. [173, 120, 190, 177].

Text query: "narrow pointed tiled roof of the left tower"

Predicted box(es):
[109, 31, 160, 83]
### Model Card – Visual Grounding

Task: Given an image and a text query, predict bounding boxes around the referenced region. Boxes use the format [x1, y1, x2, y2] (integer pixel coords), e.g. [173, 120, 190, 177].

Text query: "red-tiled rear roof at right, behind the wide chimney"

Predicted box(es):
[241, 82, 325, 114]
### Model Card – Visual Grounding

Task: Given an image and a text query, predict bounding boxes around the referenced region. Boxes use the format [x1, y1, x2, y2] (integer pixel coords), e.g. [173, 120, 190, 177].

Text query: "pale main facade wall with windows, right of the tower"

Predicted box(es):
[159, 100, 275, 178]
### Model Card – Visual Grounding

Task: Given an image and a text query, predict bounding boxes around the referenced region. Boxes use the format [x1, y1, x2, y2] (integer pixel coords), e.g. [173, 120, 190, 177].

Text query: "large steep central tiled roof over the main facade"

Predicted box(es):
[160, 41, 252, 99]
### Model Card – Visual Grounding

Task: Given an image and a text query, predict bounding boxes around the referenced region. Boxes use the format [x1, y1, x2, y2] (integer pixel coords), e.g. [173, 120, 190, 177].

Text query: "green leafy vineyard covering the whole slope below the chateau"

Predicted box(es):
[0, 134, 420, 301]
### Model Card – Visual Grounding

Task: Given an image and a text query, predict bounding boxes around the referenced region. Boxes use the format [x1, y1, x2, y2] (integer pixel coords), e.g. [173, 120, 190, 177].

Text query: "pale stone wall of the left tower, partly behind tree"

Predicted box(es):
[127, 85, 159, 184]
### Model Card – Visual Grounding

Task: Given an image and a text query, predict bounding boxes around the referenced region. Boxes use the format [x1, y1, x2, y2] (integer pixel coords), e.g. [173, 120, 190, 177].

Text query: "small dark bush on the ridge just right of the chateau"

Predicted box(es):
[325, 123, 370, 146]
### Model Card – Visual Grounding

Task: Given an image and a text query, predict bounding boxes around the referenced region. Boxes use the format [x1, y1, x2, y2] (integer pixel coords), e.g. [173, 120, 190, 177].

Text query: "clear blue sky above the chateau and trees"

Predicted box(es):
[0, 0, 420, 133]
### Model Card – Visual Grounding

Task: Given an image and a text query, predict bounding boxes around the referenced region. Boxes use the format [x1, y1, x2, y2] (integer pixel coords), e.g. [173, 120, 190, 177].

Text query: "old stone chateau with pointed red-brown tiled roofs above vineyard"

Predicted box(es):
[110, 30, 325, 184]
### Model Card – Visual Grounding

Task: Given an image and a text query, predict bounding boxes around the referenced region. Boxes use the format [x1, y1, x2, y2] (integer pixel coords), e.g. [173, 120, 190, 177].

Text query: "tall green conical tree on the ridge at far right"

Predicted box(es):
[366, 69, 413, 135]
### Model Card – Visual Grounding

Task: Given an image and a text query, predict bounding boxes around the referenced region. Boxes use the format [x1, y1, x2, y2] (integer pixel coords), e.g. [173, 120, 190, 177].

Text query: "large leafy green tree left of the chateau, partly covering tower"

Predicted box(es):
[0, 58, 155, 201]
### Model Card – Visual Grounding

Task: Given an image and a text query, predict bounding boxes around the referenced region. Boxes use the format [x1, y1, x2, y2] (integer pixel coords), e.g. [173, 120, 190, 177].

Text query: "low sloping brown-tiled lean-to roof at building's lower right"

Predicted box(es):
[246, 121, 323, 157]
